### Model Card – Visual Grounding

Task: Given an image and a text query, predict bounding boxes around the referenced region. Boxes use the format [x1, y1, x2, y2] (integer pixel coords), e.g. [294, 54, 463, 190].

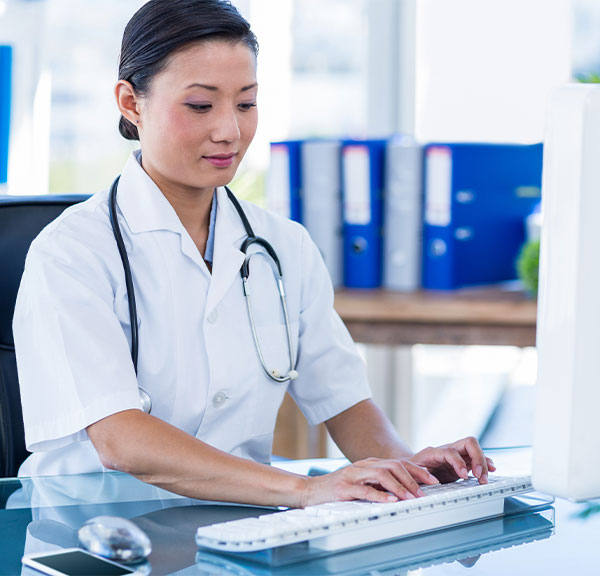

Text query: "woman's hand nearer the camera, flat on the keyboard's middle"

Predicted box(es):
[302, 458, 439, 507]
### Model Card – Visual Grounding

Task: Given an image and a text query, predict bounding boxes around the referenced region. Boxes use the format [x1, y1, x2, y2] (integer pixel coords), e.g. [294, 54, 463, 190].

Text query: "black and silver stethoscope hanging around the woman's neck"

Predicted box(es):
[108, 176, 298, 414]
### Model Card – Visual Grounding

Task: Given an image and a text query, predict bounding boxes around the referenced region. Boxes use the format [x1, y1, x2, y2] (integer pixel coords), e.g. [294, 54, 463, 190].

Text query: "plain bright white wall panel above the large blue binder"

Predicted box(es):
[416, 0, 572, 142]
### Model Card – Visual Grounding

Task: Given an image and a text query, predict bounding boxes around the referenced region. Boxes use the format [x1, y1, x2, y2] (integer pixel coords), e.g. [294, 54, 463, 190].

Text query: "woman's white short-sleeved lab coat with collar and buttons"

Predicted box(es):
[13, 153, 370, 475]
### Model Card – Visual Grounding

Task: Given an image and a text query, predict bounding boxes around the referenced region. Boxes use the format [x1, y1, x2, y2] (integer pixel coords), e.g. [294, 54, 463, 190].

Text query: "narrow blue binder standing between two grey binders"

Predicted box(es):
[342, 140, 386, 288]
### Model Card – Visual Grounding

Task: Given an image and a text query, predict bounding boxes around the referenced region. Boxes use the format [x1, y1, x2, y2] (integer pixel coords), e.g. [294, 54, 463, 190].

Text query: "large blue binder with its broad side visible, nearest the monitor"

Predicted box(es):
[423, 143, 543, 290]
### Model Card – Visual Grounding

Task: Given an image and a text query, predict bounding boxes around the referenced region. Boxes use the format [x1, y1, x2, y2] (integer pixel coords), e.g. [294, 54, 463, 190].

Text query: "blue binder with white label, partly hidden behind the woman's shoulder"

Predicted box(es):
[267, 140, 302, 222]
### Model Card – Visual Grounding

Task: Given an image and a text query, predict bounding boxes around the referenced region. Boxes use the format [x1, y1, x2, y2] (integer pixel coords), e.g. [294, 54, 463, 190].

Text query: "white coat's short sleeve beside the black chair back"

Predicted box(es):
[13, 223, 140, 451]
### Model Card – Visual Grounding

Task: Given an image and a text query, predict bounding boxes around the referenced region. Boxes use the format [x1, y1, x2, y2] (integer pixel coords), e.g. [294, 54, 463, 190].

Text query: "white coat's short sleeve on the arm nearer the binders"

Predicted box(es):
[289, 230, 371, 425]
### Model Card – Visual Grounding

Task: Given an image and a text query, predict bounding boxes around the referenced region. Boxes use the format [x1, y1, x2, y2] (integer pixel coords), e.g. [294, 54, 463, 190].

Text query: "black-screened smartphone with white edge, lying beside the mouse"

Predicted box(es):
[21, 548, 135, 576]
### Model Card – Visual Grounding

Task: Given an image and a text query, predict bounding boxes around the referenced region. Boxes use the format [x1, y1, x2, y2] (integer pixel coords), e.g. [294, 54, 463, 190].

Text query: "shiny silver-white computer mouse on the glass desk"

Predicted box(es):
[78, 516, 152, 563]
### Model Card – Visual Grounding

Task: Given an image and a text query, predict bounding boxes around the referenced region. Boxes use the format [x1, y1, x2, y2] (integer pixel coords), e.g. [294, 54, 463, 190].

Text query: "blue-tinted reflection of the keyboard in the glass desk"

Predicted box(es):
[189, 503, 554, 576]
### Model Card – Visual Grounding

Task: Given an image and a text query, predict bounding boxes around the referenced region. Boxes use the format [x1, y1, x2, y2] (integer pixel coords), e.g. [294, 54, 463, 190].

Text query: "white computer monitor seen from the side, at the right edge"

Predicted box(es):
[533, 84, 600, 500]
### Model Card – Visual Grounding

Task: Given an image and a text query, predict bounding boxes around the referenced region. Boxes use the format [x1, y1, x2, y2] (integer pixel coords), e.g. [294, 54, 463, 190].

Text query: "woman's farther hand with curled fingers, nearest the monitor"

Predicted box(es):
[408, 437, 496, 484]
